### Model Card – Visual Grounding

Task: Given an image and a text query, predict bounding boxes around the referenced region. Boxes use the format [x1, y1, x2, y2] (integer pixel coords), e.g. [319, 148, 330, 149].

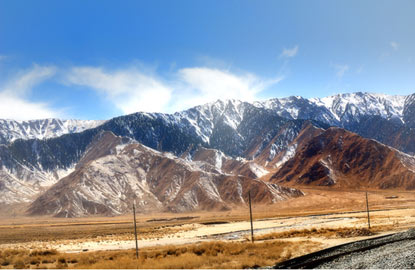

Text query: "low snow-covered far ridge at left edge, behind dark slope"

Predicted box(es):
[0, 118, 105, 144]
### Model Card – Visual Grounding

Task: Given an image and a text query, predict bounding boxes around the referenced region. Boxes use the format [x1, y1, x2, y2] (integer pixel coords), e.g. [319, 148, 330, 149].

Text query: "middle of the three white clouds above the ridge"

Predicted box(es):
[66, 67, 172, 114]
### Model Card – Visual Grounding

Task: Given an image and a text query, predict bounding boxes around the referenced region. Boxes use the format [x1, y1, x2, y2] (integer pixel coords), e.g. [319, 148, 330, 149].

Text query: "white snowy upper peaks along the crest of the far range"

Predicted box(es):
[0, 92, 408, 147]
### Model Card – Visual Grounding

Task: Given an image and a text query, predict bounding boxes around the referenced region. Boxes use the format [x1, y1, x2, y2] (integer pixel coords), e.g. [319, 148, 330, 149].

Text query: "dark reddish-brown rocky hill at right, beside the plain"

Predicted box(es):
[270, 128, 415, 190]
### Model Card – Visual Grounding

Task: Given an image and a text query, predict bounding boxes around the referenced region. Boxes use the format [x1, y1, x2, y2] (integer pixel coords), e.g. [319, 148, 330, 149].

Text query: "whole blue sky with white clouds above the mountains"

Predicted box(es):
[0, 0, 415, 120]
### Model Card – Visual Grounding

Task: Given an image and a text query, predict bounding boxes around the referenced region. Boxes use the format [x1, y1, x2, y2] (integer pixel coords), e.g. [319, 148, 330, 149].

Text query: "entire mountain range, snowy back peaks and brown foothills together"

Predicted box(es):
[0, 92, 415, 217]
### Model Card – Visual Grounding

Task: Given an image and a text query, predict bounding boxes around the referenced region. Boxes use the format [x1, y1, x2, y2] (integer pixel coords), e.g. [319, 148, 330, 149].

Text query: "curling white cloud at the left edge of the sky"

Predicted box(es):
[0, 65, 60, 120]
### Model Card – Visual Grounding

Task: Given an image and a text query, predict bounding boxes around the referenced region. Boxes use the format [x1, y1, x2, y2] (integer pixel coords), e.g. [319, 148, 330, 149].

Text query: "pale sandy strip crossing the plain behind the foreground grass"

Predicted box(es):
[0, 209, 415, 252]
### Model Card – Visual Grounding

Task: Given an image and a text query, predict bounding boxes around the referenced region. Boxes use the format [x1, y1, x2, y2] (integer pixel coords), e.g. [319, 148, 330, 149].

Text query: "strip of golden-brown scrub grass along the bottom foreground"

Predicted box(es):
[0, 241, 319, 269]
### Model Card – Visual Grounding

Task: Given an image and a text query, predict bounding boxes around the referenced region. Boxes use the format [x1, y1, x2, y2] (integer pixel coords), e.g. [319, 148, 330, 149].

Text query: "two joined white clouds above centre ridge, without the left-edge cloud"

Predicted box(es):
[66, 67, 282, 113]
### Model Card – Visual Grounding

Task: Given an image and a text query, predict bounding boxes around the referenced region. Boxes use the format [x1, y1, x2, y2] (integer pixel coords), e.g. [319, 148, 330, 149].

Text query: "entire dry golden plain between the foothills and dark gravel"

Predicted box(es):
[0, 188, 415, 269]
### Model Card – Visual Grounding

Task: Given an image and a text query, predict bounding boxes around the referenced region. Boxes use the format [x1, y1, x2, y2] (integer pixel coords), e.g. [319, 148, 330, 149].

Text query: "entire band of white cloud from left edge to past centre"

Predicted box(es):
[0, 62, 283, 120]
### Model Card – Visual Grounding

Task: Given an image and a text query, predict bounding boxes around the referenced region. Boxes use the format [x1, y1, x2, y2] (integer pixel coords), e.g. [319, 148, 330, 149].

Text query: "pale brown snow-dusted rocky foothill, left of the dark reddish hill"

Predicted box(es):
[28, 132, 303, 217]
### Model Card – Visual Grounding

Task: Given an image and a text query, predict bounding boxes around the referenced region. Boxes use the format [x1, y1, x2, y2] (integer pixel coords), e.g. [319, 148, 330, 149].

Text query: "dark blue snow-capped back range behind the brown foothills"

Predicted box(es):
[0, 93, 415, 214]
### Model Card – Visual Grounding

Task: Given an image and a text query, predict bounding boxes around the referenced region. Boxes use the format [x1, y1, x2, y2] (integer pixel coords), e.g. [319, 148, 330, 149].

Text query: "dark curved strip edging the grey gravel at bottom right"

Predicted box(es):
[272, 229, 415, 269]
